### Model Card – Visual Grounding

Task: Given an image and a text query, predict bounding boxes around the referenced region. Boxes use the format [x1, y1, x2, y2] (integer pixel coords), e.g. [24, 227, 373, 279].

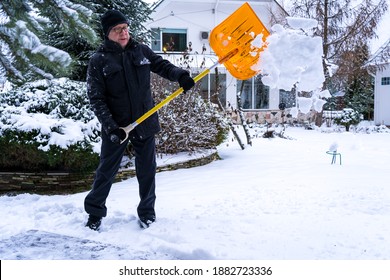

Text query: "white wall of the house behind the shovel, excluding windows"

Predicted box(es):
[146, 0, 290, 122]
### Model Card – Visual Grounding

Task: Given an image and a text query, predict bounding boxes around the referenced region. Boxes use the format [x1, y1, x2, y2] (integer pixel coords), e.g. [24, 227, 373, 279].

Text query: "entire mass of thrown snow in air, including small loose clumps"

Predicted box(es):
[251, 17, 329, 115]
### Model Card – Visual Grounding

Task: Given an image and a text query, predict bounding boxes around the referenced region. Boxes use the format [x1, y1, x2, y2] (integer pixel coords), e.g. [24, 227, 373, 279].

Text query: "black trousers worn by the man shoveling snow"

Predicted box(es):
[84, 131, 156, 220]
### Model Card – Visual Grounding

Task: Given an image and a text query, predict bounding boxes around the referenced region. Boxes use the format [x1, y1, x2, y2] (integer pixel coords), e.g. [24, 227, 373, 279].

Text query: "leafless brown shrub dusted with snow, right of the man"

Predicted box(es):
[152, 75, 228, 153]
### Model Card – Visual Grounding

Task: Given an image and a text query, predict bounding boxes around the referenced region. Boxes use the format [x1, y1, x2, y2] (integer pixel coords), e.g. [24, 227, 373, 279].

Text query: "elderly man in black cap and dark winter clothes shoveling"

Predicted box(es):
[84, 10, 195, 230]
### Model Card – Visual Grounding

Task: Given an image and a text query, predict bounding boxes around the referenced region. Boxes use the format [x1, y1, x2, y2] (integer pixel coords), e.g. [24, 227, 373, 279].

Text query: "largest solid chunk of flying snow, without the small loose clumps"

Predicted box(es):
[259, 24, 325, 92]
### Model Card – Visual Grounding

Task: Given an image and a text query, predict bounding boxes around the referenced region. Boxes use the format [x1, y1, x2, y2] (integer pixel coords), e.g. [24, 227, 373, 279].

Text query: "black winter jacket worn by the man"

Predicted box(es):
[87, 38, 188, 138]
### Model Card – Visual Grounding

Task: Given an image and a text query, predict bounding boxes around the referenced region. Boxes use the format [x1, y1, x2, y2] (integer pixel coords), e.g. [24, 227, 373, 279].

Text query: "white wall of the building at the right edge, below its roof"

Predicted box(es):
[374, 64, 390, 126]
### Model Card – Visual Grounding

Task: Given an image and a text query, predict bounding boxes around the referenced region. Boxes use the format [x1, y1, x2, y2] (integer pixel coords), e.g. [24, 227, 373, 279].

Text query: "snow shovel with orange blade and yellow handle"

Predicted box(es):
[121, 3, 269, 144]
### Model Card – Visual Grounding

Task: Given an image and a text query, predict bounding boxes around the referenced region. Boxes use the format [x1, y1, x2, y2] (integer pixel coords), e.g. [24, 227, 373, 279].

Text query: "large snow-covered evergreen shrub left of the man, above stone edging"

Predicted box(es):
[0, 79, 100, 171]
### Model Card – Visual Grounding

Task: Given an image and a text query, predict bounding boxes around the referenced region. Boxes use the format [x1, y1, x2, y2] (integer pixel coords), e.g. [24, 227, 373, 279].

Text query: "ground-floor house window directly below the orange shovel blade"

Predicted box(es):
[237, 75, 269, 110]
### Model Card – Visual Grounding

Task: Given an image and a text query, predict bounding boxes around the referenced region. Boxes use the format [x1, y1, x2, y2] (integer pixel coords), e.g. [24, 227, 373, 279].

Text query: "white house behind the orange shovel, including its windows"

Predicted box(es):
[146, 0, 295, 121]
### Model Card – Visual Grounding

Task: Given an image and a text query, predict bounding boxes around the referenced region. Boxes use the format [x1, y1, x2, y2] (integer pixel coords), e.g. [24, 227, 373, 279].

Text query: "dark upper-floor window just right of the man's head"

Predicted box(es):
[151, 28, 187, 52]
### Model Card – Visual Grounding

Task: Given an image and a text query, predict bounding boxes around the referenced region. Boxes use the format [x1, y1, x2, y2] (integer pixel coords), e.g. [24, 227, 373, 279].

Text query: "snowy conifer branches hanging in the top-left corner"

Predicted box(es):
[0, 0, 98, 84]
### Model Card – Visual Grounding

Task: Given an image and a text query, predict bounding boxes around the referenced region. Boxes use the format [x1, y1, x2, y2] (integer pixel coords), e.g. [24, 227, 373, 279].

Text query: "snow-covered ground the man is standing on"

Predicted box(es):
[0, 124, 390, 260]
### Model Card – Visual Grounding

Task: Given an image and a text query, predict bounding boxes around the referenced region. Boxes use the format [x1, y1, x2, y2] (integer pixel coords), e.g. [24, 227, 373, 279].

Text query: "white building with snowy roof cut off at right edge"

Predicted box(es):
[370, 39, 390, 126]
